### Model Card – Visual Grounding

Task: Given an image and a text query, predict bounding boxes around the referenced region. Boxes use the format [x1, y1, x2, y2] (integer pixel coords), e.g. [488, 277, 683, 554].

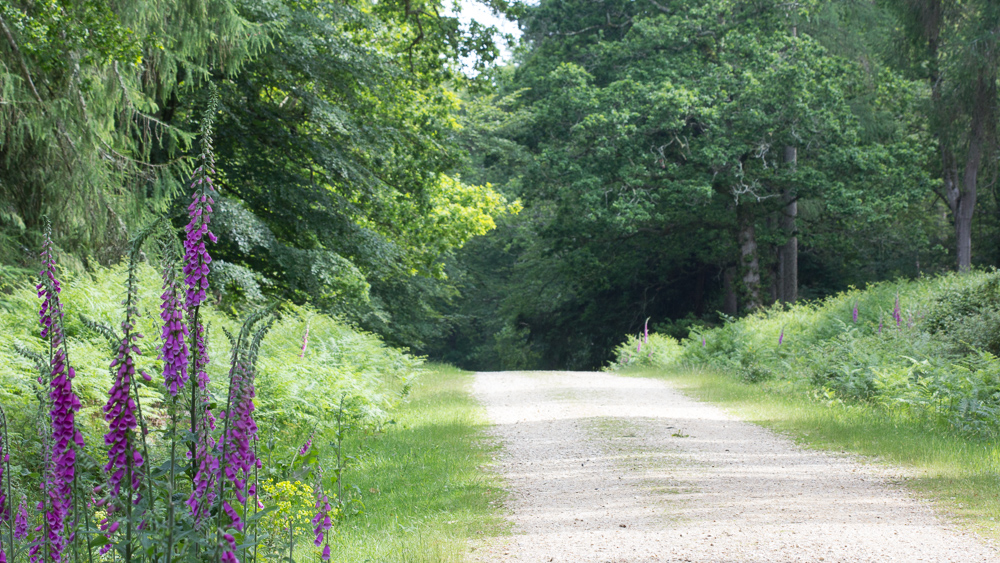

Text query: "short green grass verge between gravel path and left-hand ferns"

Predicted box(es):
[322, 365, 507, 563]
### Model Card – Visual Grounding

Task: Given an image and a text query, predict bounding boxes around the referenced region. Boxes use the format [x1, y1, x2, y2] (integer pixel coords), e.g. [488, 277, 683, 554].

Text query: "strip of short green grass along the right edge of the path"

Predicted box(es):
[624, 367, 1000, 539]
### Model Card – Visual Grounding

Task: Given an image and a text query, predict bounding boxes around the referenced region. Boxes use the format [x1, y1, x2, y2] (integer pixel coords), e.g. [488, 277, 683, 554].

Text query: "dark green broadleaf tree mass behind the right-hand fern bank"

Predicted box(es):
[428, 0, 951, 369]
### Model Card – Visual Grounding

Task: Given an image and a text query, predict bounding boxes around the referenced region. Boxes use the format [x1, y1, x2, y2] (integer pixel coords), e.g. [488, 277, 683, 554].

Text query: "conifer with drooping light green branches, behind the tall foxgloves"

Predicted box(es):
[0, 0, 266, 263]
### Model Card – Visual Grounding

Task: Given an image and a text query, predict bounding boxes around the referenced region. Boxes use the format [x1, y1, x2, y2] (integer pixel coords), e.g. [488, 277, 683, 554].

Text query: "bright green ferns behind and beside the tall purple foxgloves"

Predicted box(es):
[0, 258, 420, 560]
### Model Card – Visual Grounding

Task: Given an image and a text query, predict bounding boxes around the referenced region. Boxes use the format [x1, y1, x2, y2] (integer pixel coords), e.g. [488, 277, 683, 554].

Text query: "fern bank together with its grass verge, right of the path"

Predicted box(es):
[610, 271, 1000, 537]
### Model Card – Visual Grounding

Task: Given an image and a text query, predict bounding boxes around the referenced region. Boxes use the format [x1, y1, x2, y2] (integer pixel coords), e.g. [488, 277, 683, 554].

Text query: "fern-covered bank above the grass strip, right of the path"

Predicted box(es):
[612, 271, 1000, 439]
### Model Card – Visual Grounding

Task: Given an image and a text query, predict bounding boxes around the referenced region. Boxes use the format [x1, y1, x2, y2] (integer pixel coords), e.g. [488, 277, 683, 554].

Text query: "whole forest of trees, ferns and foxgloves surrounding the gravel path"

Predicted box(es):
[0, 0, 1000, 563]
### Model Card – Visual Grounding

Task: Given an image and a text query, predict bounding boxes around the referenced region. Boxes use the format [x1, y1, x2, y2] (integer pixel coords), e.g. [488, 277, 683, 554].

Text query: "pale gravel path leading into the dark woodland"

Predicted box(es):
[472, 372, 1000, 563]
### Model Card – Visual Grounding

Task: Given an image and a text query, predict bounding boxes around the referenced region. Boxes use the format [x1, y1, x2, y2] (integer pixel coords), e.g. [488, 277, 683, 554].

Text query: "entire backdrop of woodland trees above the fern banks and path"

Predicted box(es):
[0, 0, 1000, 369]
